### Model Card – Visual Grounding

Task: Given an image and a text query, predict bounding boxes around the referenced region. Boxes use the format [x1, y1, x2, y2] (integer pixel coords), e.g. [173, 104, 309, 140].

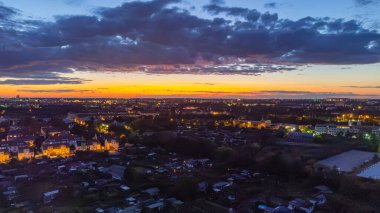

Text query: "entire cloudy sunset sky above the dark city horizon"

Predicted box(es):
[0, 0, 380, 99]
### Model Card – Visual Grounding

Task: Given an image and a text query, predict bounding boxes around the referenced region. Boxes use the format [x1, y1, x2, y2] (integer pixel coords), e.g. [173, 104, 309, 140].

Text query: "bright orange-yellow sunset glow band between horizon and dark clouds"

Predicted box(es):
[0, 65, 380, 98]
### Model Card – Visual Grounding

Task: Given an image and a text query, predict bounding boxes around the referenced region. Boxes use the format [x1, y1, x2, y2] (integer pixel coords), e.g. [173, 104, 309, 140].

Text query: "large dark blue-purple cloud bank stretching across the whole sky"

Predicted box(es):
[0, 0, 380, 83]
